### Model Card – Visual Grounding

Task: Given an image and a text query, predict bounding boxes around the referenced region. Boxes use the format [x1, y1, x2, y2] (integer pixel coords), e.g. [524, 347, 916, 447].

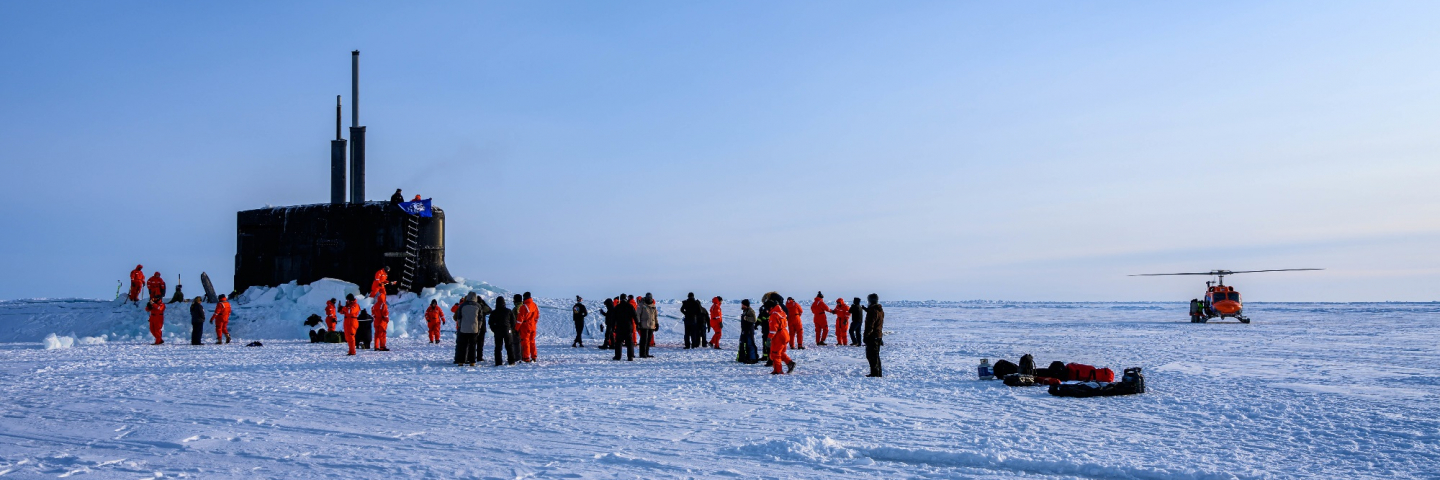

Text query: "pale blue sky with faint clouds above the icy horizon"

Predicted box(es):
[0, 1, 1440, 300]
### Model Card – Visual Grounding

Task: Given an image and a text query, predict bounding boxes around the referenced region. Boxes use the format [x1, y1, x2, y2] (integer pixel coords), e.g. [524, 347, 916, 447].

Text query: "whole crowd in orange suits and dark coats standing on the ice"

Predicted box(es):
[130, 265, 884, 376]
